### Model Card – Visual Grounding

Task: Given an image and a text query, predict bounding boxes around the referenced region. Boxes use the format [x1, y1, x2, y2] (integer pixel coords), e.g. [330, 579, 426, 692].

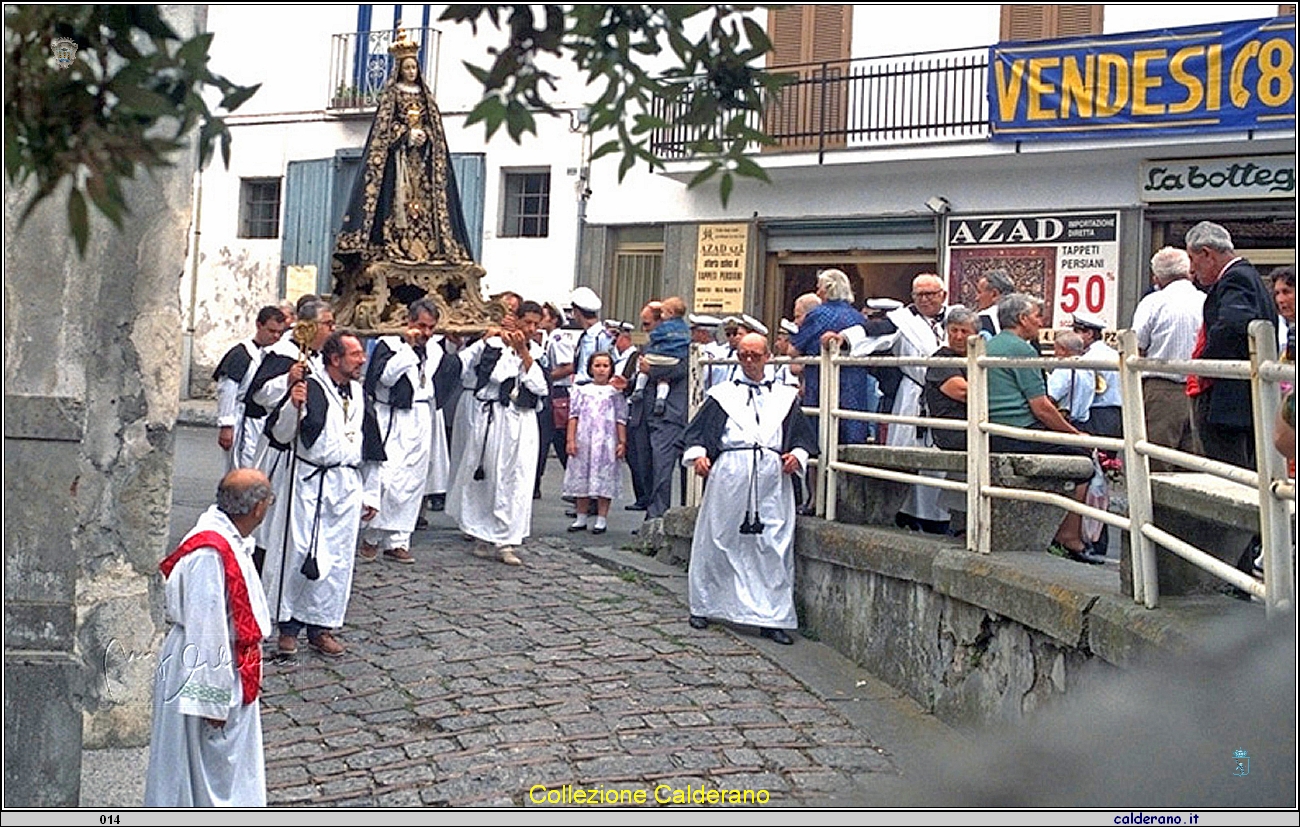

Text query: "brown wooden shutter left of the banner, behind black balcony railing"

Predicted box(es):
[766, 4, 853, 151]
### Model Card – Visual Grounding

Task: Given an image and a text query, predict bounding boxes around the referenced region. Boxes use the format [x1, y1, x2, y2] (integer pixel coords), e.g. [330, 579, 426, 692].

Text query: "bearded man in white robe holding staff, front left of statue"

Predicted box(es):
[263, 333, 384, 658]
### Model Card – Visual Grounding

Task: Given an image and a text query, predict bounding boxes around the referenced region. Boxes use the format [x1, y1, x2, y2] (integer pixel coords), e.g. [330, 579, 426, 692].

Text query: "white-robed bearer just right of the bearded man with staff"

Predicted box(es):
[360, 299, 460, 563]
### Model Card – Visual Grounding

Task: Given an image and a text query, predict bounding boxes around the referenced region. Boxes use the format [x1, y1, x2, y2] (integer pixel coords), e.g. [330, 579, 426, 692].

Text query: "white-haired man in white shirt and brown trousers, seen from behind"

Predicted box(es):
[1132, 247, 1205, 471]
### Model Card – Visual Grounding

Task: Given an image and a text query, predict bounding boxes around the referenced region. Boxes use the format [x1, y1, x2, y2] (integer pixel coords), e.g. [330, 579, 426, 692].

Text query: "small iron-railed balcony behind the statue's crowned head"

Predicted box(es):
[325, 27, 442, 114]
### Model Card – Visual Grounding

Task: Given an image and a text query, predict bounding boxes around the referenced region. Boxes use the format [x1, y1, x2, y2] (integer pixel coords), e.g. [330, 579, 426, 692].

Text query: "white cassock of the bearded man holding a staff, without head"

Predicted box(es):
[261, 369, 378, 628]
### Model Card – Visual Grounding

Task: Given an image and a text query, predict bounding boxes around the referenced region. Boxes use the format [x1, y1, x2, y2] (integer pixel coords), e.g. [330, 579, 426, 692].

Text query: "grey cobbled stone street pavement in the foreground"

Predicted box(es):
[263, 518, 898, 806]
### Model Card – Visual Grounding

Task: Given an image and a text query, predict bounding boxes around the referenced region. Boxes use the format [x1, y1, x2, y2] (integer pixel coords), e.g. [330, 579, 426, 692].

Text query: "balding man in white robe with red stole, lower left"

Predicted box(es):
[144, 468, 273, 807]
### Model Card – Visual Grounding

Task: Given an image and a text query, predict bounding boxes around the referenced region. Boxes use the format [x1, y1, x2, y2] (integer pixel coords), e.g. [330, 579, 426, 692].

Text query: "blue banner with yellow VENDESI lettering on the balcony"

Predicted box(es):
[988, 16, 1296, 140]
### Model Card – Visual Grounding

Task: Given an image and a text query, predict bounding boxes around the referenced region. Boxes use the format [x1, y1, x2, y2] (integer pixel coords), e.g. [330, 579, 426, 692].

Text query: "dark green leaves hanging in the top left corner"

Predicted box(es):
[4, 4, 257, 256]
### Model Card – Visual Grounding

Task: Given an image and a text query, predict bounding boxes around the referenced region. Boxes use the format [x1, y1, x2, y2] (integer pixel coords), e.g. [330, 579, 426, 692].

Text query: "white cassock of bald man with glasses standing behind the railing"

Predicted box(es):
[885, 306, 949, 523]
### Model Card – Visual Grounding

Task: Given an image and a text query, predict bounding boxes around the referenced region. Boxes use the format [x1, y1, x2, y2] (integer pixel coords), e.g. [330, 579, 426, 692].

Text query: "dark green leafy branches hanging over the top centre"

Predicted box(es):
[441, 4, 784, 205]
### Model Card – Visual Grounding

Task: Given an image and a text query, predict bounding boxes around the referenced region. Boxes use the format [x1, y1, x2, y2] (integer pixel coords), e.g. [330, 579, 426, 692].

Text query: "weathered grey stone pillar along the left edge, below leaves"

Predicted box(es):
[4, 7, 205, 806]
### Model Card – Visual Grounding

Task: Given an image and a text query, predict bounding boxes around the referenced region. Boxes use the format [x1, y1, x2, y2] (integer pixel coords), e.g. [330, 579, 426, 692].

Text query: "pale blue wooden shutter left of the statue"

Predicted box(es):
[280, 159, 334, 293]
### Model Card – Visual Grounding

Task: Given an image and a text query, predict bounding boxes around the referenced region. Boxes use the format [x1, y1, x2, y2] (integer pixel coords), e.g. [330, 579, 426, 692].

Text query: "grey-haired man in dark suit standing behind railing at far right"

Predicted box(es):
[1184, 221, 1277, 468]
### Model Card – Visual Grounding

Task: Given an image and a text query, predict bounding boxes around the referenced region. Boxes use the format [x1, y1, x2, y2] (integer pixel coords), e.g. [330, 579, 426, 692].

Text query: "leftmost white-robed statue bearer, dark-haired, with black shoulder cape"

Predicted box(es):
[212, 306, 285, 471]
